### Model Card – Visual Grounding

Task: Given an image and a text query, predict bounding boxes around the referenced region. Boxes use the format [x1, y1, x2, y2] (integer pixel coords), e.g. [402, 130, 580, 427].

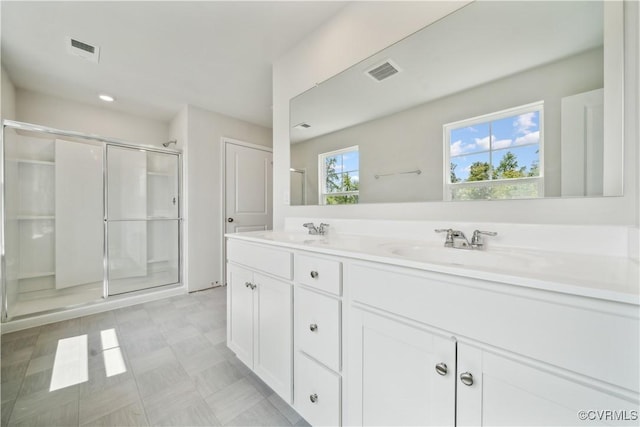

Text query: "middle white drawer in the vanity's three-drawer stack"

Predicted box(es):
[295, 288, 341, 372]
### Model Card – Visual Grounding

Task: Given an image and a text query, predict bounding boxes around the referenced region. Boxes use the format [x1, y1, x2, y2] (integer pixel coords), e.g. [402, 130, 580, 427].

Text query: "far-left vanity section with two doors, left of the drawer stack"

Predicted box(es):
[227, 239, 293, 401]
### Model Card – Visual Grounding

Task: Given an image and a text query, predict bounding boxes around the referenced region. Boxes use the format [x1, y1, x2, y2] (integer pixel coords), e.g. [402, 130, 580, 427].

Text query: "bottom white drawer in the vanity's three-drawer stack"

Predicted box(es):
[294, 352, 341, 426]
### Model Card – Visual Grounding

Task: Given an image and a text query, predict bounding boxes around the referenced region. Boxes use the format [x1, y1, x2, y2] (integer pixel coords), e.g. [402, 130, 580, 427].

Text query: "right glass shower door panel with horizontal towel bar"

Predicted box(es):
[107, 146, 180, 295]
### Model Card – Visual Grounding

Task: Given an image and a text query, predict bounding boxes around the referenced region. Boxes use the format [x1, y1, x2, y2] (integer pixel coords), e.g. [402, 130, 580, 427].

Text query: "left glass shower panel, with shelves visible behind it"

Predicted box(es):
[3, 127, 104, 321]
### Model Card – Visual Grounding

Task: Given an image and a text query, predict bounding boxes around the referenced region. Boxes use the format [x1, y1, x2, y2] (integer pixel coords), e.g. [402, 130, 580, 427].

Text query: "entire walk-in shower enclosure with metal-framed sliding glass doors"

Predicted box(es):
[1, 121, 181, 322]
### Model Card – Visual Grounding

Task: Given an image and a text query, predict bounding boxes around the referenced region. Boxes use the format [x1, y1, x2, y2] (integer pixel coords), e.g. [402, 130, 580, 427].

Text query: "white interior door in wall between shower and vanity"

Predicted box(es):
[225, 141, 273, 233]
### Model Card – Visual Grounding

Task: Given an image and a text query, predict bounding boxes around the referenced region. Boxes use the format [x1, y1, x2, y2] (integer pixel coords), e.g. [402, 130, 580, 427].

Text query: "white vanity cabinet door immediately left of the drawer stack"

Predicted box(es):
[253, 273, 293, 402]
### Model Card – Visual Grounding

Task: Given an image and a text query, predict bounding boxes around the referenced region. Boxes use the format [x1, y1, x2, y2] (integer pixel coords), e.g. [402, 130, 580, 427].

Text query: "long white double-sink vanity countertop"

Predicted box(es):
[226, 231, 640, 305]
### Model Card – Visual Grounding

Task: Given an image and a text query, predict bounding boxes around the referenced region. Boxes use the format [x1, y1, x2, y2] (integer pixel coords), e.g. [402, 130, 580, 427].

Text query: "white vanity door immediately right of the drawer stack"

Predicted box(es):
[346, 309, 456, 426]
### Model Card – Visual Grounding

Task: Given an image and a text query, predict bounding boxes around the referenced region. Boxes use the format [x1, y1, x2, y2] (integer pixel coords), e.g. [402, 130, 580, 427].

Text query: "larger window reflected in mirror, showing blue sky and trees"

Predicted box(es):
[443, 102, 544, 200]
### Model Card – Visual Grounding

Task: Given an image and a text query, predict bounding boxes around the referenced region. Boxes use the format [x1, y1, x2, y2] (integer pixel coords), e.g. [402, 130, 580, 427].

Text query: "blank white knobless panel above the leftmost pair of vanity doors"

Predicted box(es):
[227, 238, 293, 280]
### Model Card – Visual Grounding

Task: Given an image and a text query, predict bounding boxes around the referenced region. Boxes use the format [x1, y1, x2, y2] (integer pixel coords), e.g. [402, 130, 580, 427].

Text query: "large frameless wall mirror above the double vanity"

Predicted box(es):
[290, 1, 623, 205]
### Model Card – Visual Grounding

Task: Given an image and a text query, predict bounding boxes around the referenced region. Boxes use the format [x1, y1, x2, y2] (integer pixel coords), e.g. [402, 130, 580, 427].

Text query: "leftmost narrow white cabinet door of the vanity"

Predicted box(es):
[227, 264, 253, 368]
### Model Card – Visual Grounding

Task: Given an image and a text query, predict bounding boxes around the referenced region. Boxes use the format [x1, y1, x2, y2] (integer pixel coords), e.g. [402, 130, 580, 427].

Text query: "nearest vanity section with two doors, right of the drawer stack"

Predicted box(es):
[345, 262, 639, 426]
